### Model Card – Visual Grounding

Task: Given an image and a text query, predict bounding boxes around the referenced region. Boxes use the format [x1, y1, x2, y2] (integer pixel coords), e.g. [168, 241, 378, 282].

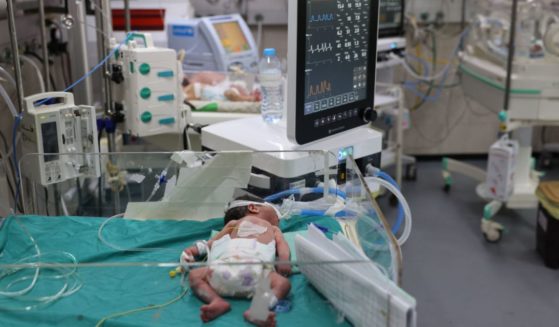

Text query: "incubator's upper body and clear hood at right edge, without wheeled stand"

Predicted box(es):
[460, 0, 559, 121]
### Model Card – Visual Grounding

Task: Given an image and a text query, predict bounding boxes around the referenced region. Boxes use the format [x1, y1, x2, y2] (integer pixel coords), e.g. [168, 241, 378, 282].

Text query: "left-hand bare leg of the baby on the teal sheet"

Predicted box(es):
[188, 268, 231, 322]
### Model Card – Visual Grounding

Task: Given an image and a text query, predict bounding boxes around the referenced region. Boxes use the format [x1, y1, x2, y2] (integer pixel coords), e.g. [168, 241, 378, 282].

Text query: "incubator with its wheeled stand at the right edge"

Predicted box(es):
[443, 0, 559, 242]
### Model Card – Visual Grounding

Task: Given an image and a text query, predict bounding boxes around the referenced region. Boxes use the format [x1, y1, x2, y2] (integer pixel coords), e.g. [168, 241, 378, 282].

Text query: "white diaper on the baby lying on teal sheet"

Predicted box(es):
[208, 235, 276, 297]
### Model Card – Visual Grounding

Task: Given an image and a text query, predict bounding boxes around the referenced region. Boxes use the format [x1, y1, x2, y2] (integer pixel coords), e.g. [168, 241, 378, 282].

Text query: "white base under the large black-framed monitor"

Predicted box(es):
[202, 116, 382, 178]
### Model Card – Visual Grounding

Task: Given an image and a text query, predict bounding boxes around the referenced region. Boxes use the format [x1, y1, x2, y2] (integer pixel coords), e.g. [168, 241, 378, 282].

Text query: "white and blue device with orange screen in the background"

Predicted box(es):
[167, 14, 259, 72]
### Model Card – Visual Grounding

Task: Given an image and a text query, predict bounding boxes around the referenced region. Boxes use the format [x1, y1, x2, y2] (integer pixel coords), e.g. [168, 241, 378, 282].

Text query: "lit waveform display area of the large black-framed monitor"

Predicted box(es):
[304, 0, 376, 115]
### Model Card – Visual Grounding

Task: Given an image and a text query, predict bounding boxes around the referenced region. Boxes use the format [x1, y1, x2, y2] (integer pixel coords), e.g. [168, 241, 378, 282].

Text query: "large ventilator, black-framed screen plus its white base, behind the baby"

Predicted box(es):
[202, 1, 382, 184]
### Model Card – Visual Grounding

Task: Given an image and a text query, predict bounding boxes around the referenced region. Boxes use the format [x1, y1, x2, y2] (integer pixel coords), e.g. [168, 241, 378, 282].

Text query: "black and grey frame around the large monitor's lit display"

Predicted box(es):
[287, 0, 379, 144]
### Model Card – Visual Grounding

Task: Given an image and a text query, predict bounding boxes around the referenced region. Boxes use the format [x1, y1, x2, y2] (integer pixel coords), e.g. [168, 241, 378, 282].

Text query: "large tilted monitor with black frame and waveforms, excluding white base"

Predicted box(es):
[287, 0, 379, 144]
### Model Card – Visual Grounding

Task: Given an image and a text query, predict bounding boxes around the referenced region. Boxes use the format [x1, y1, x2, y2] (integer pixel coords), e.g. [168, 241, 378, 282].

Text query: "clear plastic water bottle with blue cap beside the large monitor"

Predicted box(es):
[258, 48, 284, 124]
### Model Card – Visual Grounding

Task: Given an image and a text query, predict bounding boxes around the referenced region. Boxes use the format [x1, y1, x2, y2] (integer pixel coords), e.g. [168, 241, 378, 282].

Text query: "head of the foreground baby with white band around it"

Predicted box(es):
[224, 195, 280, 226]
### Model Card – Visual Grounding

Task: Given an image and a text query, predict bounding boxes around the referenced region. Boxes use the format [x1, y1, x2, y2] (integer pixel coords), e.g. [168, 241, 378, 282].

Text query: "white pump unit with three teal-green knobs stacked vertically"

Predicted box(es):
[111, 33, 186, 137]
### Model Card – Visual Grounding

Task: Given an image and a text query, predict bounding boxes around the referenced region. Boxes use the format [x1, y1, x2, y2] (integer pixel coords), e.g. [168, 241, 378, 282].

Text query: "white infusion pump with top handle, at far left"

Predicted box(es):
[21, 92, 100, 186]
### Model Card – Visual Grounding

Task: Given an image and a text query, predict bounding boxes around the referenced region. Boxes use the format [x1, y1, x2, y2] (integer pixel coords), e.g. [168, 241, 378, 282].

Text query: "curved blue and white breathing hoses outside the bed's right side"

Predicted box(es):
[365, 165, 412, 245]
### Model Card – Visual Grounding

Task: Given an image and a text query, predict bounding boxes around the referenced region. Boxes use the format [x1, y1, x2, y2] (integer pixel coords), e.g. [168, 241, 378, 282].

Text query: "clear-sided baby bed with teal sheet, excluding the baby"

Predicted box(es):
[0, 151, 416, 326]
